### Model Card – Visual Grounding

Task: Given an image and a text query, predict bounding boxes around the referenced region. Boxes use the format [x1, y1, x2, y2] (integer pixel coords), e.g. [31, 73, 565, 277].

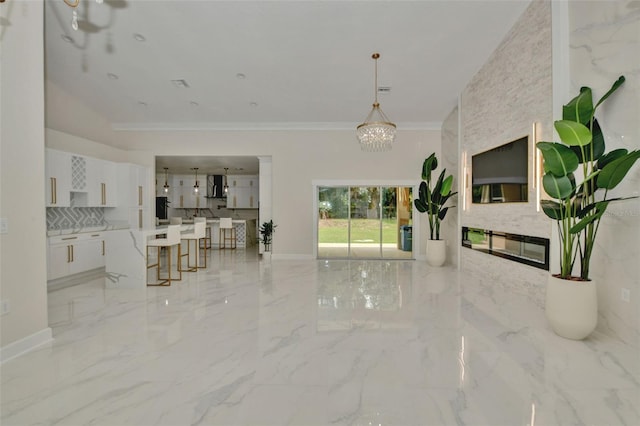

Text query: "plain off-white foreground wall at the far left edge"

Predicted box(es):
[0, 0, 51, 359]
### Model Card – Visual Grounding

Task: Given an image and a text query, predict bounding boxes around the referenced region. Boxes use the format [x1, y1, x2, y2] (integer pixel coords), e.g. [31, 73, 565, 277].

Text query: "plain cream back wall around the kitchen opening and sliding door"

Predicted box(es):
[111, 130, 440, 257]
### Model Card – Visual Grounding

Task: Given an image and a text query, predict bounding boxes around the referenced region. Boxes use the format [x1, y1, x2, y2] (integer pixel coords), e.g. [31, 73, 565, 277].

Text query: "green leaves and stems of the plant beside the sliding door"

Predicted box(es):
[414, 152, 457, 240]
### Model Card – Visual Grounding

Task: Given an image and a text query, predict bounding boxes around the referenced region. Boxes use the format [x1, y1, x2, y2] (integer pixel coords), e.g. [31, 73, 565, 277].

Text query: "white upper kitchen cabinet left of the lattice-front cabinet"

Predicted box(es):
[45, 149, 71, 207]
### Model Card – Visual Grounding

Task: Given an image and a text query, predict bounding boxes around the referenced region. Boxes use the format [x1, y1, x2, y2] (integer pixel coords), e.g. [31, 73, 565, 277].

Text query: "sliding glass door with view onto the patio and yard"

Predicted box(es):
[317, 186, 413, 259]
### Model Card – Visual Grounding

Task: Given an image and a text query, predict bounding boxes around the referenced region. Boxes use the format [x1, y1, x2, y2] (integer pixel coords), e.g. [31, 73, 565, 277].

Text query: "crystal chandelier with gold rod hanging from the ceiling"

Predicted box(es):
[356, 53, 396, 151]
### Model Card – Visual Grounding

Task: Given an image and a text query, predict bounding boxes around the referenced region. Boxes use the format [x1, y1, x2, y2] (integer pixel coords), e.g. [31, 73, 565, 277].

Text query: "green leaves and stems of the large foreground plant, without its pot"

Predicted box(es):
[537, 76, 640, 280]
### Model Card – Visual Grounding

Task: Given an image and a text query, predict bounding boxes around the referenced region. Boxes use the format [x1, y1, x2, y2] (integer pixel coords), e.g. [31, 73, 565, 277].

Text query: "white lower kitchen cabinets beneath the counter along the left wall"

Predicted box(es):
[47, 233, 105, 280]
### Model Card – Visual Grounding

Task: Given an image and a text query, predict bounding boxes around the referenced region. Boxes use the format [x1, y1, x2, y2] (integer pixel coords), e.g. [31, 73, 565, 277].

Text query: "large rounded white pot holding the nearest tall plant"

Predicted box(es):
[545, 275, 598, 340]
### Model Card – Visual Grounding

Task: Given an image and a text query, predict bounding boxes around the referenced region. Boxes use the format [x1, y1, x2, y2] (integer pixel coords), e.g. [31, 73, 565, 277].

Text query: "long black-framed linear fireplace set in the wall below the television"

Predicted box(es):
[462, 226, 549, 271]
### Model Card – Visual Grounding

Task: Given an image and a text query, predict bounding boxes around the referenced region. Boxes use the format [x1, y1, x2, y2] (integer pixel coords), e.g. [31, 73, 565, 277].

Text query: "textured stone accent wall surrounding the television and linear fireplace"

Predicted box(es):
[459, 0, 553, 307]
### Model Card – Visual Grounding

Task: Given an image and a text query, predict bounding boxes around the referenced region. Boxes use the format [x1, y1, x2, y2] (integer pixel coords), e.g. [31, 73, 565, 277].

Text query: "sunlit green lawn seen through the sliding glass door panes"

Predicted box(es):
[318, 219, 398, 244]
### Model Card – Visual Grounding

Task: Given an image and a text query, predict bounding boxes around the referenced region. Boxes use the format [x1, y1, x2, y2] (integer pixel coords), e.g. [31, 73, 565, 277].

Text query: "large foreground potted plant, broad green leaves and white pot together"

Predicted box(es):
[537, 76, 640, 340]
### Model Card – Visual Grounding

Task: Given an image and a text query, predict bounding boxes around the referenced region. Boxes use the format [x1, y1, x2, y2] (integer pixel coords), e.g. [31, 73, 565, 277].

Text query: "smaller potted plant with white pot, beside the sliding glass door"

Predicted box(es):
[414, 152, 457, 266]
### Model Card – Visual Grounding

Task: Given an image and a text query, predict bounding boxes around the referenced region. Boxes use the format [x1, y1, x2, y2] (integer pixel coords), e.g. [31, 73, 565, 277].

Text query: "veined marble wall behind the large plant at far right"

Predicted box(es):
[564, 0, 640, 347]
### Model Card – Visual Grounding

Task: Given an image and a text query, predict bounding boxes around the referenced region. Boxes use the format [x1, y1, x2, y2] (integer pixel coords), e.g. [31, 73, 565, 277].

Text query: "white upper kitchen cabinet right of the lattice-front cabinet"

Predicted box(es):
[86, 158, 118, 207]
